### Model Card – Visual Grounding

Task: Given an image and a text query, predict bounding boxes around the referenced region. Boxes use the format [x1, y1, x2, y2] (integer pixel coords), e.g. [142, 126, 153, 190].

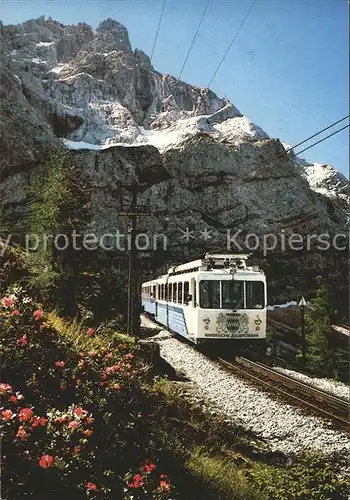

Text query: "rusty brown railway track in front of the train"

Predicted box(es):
[217, 357, 350, 431]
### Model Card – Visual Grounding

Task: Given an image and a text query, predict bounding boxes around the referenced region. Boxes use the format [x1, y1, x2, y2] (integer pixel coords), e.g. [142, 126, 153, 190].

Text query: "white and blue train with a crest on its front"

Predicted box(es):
[141, 254, 267, 344]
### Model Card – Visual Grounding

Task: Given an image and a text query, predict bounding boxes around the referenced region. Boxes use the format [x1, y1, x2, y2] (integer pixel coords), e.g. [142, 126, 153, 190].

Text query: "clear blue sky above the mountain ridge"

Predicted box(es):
[0, 0, 349, 175]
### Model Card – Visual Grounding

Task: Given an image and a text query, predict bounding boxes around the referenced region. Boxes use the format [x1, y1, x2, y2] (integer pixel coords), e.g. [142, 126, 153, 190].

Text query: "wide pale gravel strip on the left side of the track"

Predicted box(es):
[140, 320, 350, 458]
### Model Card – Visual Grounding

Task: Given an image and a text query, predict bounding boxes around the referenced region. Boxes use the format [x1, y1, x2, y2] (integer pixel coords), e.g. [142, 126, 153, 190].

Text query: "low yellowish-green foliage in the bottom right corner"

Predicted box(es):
[246, 453, 349, 500]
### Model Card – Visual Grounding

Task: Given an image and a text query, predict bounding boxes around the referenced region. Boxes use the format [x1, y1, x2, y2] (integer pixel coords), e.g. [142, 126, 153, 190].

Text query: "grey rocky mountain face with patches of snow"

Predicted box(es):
[0, 18, 347, 258]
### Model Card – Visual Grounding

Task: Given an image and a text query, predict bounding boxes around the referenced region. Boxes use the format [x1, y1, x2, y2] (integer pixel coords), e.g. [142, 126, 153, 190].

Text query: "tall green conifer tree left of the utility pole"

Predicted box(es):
[27, 145, 91, 316]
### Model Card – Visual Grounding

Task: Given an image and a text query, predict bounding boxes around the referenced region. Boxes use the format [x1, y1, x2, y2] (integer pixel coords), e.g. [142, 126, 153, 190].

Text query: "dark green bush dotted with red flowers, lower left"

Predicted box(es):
[0, 287, 170, 500]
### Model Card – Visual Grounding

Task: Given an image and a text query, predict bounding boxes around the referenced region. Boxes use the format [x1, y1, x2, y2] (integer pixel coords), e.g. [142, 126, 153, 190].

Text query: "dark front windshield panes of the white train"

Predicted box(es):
[199, 280, 265, 309]
